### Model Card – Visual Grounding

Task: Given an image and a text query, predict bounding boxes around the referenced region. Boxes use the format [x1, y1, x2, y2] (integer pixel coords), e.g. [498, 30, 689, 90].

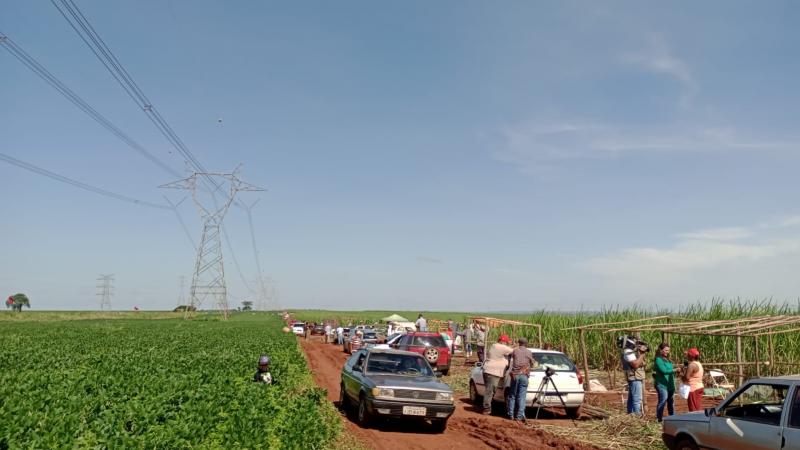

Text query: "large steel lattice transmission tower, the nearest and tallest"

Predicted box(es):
[160, 167, 264, 319]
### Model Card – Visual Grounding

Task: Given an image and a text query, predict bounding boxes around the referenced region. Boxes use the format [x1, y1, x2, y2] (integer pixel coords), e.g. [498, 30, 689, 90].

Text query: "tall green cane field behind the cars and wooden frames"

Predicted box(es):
[291, 300, 800, 375]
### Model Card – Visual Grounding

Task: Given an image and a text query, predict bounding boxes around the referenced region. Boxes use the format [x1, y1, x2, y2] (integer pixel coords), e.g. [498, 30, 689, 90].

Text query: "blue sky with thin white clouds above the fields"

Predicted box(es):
[0, 0, 800, 310]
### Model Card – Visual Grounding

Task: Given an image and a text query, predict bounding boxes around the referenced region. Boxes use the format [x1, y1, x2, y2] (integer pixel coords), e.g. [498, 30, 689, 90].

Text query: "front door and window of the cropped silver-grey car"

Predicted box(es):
[703, 381, 789, 450]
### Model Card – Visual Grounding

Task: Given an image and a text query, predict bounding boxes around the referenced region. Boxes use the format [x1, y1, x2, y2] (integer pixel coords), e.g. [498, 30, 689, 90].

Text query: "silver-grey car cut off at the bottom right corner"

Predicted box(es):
[661, 375, 800, 450]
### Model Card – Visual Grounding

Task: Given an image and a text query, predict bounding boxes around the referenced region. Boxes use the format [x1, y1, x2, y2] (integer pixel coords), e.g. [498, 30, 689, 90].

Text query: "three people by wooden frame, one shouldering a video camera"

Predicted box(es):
[622, 342, 705, 422]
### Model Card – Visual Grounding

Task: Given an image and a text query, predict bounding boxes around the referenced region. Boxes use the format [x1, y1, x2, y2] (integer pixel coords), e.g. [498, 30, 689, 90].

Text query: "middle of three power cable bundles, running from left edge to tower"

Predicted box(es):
[0, 31, 180, 176]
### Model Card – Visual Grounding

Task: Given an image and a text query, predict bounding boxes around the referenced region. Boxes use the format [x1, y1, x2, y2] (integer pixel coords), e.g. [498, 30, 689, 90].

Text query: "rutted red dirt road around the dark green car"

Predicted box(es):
[300, 338, 597, 450]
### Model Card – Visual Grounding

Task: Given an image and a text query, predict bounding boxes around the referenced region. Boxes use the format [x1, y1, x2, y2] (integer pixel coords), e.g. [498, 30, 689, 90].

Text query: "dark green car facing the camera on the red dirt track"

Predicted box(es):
[339, 348, 455, 432]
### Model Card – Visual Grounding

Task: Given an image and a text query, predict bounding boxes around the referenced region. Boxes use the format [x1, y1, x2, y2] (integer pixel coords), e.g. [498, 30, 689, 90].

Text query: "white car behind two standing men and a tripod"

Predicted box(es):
[469, 348, 584, 418]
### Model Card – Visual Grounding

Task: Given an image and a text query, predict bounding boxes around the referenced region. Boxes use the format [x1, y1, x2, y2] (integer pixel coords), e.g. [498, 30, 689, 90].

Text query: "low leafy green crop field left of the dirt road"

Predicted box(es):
[0, 313, 342, 448]
